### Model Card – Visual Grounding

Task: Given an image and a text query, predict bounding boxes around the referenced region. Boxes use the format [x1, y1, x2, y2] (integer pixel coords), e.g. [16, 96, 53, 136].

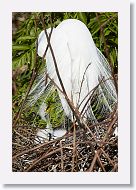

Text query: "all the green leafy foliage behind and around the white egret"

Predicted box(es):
[12, 12, 118, 127]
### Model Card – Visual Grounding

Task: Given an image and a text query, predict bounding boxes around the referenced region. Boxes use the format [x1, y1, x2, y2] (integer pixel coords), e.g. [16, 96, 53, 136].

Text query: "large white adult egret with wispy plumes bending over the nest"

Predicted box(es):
[30, 19, 117, 141]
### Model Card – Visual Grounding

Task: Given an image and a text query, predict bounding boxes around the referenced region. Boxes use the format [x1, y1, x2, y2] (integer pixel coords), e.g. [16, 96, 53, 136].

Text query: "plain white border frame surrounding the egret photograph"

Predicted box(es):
[0, 0, 130, 184]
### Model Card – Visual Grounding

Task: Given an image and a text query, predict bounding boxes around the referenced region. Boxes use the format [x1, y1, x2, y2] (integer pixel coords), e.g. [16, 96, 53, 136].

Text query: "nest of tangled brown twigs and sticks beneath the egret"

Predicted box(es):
[12, 108, 118, 172]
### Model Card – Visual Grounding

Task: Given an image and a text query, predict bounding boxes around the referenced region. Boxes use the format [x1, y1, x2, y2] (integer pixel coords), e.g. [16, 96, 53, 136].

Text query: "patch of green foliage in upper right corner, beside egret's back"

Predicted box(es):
[87, 12, 118, 70]
